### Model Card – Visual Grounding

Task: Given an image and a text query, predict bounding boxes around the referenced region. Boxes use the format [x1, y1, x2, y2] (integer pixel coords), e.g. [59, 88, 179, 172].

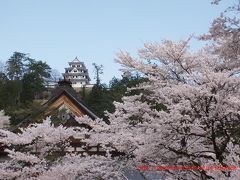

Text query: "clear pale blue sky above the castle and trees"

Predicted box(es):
[0, 0, 230, 83]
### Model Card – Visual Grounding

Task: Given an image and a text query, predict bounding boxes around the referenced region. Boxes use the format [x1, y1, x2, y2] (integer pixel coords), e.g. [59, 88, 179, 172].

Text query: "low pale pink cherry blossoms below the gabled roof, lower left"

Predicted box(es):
[0, 118, 126, 180]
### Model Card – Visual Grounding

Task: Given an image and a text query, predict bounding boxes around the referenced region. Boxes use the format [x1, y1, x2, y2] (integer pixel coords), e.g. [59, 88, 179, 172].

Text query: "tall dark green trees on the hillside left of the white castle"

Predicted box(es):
[0, 52, 51, 124]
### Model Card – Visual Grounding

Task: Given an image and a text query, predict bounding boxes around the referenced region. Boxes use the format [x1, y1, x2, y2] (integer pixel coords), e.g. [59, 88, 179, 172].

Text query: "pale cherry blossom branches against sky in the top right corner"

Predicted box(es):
[200, 0, 240, 70]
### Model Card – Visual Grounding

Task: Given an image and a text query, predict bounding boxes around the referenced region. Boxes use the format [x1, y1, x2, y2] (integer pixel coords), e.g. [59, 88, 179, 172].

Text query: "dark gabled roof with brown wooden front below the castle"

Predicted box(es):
[16, 79, 98, 128]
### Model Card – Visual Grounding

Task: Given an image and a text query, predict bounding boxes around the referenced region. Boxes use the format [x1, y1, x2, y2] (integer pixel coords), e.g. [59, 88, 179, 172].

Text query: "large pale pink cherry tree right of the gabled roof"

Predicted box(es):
[78, 37, 240, 179]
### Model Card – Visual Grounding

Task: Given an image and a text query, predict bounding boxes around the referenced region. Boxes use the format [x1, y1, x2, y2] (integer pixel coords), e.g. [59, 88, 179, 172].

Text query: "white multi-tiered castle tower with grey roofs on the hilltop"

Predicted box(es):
[63, 57, 90, 88]
